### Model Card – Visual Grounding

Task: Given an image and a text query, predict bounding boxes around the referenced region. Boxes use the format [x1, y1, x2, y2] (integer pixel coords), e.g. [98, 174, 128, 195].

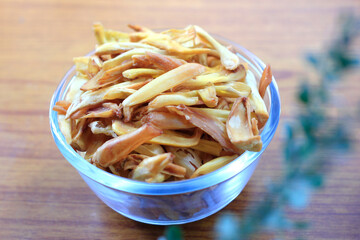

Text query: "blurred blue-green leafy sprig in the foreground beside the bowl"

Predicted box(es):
[166, 14, 360, 240]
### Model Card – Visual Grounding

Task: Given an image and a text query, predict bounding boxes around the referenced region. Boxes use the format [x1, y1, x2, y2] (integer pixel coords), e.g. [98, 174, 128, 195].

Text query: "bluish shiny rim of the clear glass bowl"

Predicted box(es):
[49, 34, 281, 195]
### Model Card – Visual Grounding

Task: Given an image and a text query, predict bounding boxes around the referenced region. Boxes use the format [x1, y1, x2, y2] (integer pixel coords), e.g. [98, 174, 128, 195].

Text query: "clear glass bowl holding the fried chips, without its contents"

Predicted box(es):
[49, 36, 280, 225]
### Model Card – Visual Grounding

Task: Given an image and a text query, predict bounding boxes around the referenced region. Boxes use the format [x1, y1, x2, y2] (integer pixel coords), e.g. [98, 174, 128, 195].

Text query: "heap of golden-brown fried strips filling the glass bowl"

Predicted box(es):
[53, 23, 272, 182]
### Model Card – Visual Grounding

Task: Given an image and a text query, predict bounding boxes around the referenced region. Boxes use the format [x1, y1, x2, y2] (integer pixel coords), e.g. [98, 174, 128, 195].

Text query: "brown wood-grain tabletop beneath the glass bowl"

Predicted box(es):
[0, 0, 360, 239]
